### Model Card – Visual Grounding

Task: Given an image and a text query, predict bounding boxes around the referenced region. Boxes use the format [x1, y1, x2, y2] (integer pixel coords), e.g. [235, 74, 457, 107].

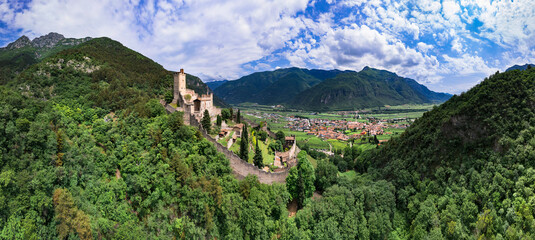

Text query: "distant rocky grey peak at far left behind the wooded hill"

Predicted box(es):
[0, 32, 91, 84]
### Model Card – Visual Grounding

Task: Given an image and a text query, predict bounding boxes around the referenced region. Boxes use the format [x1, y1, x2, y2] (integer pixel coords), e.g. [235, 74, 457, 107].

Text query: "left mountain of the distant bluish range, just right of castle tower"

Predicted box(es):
[214, 68, 342, 104]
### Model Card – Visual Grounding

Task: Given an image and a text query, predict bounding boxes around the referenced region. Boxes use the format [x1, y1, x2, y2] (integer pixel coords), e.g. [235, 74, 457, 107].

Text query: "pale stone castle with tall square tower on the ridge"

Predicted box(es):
[171, 69, 221, 123]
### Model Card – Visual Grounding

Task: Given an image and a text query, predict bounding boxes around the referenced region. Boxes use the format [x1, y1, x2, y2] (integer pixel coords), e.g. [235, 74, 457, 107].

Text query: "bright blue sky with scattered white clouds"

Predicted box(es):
[0, 0, 535, 94]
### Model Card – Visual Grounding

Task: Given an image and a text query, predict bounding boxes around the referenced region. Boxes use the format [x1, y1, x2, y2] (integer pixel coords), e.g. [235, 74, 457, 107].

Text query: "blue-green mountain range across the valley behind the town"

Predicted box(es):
[212, 67, 451, 111]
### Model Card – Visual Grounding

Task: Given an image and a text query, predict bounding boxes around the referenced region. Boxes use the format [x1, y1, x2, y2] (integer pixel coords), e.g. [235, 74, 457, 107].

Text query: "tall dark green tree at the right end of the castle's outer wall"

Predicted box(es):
[286, 151, 316, 209]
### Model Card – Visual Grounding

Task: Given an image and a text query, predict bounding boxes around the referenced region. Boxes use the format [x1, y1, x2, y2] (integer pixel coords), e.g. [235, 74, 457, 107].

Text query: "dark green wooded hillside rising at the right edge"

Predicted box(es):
[356, 69, 535, 239]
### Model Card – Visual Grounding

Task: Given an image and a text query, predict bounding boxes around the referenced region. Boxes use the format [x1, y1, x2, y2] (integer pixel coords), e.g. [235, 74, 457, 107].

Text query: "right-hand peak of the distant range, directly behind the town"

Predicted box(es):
[290, 67, 451, 111]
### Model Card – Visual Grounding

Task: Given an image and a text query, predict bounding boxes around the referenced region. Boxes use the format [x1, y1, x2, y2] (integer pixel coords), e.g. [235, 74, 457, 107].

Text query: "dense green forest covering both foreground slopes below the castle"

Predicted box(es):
[0, 38, 535, 239]
